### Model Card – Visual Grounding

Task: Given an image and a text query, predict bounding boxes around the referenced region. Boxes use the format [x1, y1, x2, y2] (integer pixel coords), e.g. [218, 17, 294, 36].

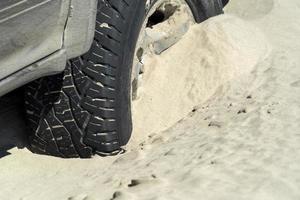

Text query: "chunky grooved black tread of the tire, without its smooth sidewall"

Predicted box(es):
[26, 1, 132, 158]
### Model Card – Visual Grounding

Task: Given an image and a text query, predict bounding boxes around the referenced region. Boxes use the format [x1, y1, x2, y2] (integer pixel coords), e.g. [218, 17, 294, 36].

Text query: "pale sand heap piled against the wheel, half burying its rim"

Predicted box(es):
[133, 16, 270, 145]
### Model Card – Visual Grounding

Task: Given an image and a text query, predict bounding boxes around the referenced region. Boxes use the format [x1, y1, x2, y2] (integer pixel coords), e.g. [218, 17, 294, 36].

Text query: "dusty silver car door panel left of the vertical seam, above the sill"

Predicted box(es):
[0, 0, 70, 80]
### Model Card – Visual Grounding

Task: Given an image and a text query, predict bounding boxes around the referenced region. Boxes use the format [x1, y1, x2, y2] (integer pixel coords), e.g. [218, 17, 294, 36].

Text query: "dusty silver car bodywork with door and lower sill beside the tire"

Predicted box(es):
[0, 0, 97, 96]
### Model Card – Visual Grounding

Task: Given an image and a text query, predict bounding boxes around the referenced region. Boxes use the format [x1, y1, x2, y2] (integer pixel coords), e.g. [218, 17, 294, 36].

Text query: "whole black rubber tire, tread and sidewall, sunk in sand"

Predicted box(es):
[25, 0, 223, 158]
